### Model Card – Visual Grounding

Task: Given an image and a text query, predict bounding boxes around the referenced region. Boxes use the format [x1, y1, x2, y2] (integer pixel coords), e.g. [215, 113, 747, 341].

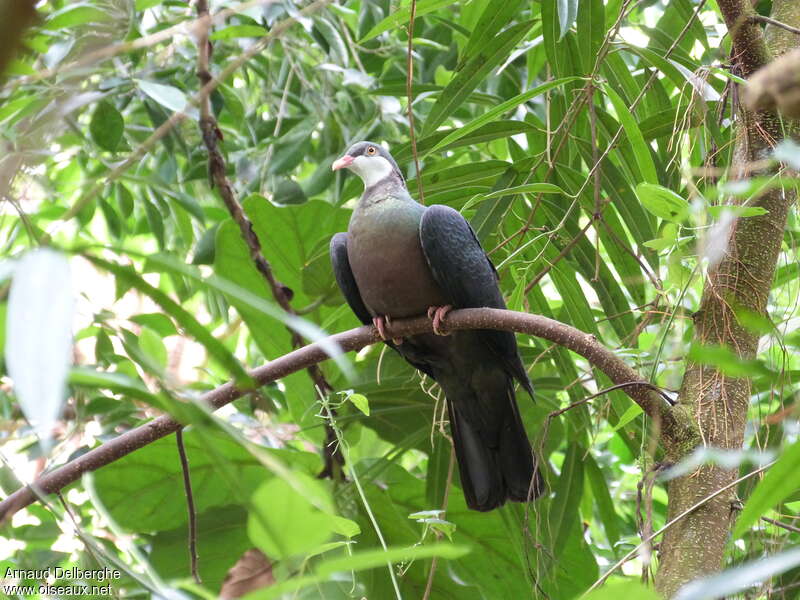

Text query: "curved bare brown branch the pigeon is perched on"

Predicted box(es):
[0, 308, 695, 523]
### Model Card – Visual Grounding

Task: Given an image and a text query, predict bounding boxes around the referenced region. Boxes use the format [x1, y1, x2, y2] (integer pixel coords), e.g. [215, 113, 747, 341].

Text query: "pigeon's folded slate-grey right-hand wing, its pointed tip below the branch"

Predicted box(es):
[419, 205, 533, 394]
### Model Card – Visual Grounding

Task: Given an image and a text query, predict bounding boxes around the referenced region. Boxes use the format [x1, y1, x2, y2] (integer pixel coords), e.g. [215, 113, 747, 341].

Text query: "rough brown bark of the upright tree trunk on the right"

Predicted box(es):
[656, 0, 798, 598]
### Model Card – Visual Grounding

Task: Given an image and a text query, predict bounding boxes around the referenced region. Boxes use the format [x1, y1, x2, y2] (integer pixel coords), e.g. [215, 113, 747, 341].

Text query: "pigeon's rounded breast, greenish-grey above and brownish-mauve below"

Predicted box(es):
[347, 198, 447, 317]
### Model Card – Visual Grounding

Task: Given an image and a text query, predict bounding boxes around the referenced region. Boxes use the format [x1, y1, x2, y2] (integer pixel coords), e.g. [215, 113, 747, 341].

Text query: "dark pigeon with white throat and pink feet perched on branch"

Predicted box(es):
[330, 141, 545, 511]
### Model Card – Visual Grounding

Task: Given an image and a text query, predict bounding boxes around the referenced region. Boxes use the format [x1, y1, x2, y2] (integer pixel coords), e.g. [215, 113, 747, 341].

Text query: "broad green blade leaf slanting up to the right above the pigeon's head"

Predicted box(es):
[422, 21, 533, 135]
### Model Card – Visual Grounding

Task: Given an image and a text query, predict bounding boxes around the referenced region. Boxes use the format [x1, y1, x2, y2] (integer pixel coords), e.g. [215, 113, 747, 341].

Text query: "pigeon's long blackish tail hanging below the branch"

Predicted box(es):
[445, 376, 544, 511]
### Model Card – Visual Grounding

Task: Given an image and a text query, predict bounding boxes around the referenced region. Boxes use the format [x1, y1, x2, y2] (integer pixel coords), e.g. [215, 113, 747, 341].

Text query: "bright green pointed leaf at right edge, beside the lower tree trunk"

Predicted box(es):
[733, 441, 800, 538]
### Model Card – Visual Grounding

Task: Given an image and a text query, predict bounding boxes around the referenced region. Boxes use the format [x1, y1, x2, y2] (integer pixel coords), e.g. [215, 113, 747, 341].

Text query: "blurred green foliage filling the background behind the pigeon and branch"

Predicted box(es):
[0, 0, 800, 600]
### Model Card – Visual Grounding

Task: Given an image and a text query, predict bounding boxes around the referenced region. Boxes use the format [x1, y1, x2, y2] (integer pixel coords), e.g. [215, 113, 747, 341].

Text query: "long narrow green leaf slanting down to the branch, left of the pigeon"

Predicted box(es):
[84, 254, 252, 387]
